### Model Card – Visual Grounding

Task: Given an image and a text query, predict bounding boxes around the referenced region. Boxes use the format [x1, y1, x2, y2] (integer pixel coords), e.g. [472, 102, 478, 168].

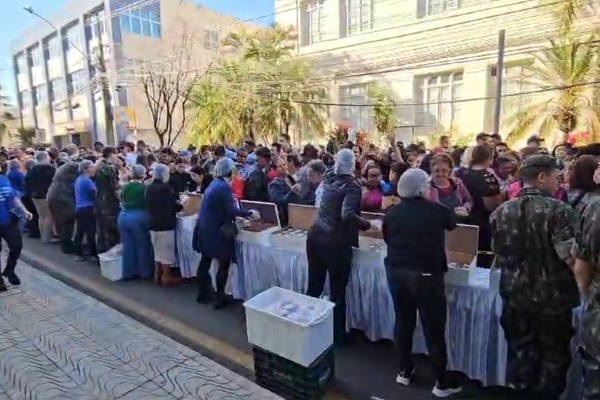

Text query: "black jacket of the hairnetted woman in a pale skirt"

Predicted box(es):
[146, 181, 181, 231]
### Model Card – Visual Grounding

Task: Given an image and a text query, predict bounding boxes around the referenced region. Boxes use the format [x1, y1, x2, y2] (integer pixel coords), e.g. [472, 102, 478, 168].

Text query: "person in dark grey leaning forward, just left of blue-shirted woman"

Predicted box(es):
[47, 162, 79, 254]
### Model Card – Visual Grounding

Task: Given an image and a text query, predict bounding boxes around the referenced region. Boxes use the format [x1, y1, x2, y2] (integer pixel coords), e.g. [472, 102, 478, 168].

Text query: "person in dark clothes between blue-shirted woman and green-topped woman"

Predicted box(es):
[94, 147, 121, 254]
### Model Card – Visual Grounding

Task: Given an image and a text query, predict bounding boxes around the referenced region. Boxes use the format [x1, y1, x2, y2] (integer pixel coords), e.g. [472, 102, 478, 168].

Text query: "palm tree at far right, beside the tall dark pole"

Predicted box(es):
[505, 36, 600, 144]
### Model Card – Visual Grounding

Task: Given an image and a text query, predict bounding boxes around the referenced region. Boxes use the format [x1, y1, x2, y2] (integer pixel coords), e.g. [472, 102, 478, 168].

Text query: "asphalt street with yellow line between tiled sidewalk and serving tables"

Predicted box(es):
[21, 238, 509, 400]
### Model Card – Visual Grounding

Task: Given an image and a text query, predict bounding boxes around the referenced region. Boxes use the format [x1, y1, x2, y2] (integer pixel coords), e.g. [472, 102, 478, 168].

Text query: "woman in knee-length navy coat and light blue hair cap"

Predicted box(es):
[193, 158, 260, 309]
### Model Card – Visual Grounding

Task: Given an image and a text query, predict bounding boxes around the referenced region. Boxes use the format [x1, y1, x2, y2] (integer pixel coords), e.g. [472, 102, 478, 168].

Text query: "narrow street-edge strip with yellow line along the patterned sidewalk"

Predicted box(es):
[21, 249, 354, 400]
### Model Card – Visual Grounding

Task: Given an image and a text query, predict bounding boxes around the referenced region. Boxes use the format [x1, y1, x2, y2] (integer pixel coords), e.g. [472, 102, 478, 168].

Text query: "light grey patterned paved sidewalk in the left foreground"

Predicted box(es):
[0, 262, 280, 400]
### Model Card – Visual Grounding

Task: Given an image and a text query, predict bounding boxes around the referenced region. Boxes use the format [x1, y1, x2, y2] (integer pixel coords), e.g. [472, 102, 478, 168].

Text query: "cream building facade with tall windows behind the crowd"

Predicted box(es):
[275, 0, 597, 142]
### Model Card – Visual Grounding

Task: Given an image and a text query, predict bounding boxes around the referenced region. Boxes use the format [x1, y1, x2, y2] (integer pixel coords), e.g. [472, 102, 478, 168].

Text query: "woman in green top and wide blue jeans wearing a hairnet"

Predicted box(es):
[118, 164, 154, 279]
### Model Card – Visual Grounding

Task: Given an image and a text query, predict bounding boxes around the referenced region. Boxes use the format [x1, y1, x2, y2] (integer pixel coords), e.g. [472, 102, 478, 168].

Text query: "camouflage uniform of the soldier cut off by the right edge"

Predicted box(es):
[572, 192, 600, 400]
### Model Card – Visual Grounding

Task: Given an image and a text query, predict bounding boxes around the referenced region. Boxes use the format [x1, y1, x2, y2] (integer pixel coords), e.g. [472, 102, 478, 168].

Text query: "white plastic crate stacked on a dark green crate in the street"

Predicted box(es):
[244, 286, 334, 367]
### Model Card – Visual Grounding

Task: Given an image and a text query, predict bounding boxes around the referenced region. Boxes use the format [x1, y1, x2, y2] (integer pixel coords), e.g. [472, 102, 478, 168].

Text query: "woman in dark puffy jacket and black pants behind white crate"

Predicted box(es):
[306, 149, 377, 345]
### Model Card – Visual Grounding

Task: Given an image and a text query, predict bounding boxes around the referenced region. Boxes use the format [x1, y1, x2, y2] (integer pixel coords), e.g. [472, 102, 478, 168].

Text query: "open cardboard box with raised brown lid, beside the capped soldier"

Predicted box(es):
[446, 224, 479, 286]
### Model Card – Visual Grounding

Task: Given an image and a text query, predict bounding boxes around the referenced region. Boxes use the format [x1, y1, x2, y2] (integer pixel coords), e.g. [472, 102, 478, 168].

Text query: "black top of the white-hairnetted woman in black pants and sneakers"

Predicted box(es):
[383, 198, 456, 274]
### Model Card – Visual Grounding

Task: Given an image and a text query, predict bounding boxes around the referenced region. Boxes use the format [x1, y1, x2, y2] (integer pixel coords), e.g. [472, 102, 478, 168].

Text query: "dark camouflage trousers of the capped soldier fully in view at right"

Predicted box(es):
[500, 303, 574, 399]
